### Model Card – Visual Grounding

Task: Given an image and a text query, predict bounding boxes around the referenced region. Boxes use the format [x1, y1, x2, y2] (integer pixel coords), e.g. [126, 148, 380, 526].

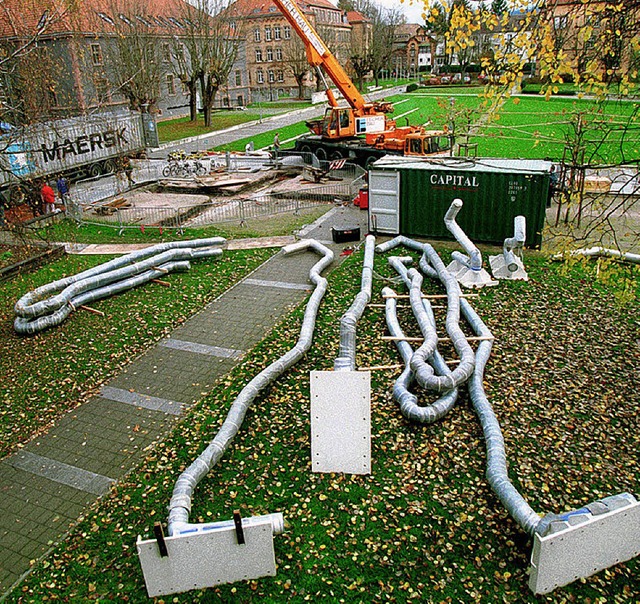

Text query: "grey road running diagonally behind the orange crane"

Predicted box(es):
[149, 85, 406, 159]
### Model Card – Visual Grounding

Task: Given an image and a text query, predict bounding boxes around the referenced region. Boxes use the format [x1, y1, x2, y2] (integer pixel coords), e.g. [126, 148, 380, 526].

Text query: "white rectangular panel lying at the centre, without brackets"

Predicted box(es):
[311, 371, 371, 474]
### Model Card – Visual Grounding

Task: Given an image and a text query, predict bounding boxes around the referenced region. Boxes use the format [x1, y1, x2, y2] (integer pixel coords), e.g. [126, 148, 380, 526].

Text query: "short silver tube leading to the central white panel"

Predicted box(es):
[333, 235, 376, 371]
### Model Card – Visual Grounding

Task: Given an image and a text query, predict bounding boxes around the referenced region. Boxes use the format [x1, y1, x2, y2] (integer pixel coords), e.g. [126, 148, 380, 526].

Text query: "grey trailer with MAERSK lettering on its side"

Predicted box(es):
[0, 111, 152, 204]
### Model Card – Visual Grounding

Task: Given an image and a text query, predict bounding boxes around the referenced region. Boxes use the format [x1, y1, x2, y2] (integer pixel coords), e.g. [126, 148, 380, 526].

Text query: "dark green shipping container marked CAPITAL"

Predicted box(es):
[369, 156, 551, 247]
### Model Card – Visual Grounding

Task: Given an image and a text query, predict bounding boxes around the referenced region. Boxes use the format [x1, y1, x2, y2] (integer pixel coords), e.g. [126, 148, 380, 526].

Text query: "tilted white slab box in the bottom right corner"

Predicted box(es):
[529, 493, 640, 594]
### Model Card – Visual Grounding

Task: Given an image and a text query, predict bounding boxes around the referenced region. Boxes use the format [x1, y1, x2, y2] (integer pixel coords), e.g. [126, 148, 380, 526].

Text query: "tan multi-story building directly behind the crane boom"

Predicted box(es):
[230, 0, 360, 101]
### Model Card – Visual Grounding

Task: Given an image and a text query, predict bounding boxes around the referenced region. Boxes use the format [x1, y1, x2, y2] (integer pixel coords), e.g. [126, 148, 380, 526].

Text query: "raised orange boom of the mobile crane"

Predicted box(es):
[273, 0, 388, 116]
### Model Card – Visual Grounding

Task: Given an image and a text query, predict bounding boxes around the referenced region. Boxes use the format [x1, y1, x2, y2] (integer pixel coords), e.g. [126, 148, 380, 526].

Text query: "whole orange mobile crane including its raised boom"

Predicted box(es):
[273, 0, 451, 164]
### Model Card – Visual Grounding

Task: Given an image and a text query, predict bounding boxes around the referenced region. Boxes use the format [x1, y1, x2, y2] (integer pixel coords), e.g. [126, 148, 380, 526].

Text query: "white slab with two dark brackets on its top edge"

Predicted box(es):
[136, 519, 276, 598]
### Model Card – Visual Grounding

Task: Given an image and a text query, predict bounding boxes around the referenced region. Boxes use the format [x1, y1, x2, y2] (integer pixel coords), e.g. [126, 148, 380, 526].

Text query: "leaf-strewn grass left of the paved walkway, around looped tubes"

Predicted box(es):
[0, 249, 275, 457]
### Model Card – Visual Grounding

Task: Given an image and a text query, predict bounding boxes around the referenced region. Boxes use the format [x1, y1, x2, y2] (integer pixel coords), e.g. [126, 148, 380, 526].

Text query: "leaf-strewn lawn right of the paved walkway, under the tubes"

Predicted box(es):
[7, 244, 640, 603]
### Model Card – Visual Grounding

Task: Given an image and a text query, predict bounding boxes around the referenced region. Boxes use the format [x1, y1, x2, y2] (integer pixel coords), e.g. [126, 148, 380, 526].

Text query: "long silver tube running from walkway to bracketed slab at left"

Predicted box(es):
[169, 239, 333, 535]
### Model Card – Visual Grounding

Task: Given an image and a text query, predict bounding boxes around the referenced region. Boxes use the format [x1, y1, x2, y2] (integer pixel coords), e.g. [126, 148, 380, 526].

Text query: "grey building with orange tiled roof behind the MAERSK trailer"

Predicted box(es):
[0, 0, 249, 121]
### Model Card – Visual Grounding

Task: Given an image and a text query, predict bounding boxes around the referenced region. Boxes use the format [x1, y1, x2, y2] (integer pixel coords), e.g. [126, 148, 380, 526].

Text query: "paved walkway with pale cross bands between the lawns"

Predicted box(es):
[0, 206, 367, 600]
